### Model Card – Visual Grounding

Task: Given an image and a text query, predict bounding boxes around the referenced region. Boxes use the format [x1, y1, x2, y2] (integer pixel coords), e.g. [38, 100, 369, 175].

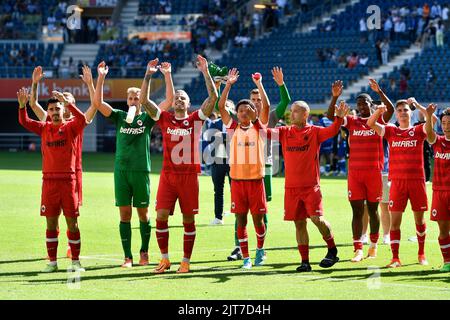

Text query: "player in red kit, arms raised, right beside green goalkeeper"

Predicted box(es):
[140, 55, 218, 273]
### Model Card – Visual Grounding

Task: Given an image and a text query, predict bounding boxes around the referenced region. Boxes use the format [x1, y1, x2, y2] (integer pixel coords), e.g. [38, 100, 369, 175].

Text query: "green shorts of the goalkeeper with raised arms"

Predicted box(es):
[114, 170, 150, 208]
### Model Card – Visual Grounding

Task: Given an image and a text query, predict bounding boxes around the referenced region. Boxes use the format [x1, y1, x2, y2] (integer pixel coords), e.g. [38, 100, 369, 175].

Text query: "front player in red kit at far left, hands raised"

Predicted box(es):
[17, 88, 86, 272]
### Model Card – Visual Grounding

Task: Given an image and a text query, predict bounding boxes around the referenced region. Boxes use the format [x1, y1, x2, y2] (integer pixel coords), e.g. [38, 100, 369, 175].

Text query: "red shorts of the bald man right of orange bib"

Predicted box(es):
[284, 186, 323, 221]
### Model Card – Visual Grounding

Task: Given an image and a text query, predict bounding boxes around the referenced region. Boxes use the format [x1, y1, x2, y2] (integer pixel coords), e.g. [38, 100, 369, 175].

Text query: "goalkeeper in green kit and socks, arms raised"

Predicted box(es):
[94, 59, 175, 268]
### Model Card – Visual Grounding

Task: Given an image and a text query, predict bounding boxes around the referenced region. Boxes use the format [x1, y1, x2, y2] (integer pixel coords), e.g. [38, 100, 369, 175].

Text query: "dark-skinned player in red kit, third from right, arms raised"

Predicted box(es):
[328, 79, 394, 262]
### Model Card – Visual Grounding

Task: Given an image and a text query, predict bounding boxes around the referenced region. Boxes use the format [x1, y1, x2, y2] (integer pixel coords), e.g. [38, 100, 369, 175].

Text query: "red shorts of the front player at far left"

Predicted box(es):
[41, 179, 80, 218]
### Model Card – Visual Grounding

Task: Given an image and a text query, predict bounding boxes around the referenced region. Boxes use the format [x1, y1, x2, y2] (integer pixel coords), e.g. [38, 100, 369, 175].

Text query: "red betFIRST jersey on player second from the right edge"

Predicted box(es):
[384, 124, 427, 180]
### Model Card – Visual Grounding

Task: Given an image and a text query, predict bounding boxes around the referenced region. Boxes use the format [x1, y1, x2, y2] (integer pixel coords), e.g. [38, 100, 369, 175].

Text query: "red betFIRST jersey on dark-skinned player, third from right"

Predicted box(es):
[343, 116, 384, 171]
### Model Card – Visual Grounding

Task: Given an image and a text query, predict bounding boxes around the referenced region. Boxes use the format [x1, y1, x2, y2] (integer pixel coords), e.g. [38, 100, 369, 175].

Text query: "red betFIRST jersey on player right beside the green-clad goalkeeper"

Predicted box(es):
[154, 110, 206, 174]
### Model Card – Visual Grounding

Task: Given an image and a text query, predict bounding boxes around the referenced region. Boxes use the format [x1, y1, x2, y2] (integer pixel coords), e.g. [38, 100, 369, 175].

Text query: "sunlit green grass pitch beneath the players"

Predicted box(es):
[0, 153, 450, 300]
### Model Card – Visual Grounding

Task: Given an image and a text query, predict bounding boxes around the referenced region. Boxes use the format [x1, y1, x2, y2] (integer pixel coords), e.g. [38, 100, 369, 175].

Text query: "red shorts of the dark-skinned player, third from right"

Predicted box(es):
[348, 170, 383, 202]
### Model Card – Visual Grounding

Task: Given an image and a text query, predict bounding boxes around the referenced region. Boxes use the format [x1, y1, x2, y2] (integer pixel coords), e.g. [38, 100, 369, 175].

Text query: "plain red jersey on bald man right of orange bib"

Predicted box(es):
[267, 117, 342, 188]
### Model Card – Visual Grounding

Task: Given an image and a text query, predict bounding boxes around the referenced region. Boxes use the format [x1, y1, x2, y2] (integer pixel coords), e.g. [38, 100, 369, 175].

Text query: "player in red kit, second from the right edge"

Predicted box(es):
[367, 98, 436, 268]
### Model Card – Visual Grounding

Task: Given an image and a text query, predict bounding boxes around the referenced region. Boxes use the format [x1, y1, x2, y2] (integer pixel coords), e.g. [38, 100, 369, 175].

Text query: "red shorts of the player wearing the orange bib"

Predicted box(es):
[231, 179, 267, 215]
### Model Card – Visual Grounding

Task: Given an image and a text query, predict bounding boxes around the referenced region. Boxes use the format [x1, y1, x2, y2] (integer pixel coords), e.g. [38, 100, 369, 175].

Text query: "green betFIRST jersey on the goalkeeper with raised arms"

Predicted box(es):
[109, 109, 155, 172]
